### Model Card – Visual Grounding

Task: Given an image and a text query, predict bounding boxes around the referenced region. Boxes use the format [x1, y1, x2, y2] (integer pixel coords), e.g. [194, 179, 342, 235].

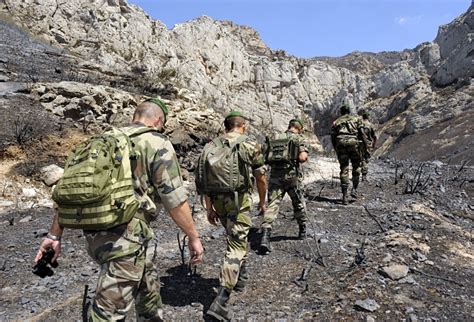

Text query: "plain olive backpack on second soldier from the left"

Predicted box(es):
[195, 135, 252, 196]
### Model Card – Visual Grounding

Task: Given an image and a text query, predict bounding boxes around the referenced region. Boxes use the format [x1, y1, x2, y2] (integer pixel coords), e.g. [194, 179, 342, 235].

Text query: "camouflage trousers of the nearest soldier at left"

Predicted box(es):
[85, 218, 162, 321]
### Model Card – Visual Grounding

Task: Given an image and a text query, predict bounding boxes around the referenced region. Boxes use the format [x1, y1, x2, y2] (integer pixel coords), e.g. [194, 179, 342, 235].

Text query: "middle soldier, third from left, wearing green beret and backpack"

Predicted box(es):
[260, 119, 308, 254]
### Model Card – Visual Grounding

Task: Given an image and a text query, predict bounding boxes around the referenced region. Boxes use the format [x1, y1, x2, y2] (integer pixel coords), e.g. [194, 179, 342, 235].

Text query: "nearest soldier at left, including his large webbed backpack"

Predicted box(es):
[35, 99, 203, 321]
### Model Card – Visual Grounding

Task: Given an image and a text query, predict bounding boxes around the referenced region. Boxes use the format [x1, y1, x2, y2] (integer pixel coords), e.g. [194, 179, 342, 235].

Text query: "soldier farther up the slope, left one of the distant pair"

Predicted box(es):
[331, 103, 362, 205]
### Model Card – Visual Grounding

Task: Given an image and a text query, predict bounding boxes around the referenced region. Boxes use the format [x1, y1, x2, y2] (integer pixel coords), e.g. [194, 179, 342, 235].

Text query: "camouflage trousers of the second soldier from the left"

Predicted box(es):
[212, 193, 252, 289]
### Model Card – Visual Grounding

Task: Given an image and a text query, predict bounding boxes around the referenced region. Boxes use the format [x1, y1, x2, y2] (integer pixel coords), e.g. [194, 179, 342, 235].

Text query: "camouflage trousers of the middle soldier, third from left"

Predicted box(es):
[262, 177, 306, 229]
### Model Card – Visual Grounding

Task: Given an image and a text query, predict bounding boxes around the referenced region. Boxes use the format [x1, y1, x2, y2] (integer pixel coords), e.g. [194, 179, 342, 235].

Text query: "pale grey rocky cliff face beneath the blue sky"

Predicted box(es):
[0, 0, 474, 161]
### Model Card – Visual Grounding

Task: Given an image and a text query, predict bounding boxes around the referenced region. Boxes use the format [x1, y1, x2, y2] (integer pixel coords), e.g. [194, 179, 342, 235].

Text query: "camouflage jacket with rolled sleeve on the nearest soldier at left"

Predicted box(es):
[84, 124, 188, 264]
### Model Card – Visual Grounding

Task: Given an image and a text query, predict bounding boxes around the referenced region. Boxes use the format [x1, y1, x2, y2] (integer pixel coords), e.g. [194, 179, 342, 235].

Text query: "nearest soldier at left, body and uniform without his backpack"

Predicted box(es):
[35, 99, 203, 321]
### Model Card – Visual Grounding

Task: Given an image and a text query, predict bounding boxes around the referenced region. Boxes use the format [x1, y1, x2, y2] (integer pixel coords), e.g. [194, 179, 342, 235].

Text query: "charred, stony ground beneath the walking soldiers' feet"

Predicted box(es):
[0, 159, 474, 321]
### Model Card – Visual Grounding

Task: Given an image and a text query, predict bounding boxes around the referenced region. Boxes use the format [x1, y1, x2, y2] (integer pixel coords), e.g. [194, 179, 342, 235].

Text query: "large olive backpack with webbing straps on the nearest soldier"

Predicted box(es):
[52, 128, 154, 230]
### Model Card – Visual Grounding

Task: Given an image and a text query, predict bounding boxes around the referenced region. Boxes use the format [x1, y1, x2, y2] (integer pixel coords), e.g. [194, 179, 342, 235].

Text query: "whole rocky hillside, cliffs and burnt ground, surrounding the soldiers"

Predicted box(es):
[0, 0, 474, 321]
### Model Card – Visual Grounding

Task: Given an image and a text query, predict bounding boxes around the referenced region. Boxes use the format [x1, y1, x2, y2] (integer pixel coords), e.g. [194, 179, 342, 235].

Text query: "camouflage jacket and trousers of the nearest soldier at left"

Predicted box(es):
[84, 125, 187, 321]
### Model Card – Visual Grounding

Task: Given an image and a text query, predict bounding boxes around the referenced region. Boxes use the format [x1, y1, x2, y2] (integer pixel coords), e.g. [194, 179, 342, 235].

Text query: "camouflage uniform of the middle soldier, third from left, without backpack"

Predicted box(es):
[262, 131, 308, 229]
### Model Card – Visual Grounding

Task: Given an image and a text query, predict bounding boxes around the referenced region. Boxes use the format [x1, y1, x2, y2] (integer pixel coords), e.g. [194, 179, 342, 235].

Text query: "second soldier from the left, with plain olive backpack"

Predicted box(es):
[196, 111, 267, 320]
